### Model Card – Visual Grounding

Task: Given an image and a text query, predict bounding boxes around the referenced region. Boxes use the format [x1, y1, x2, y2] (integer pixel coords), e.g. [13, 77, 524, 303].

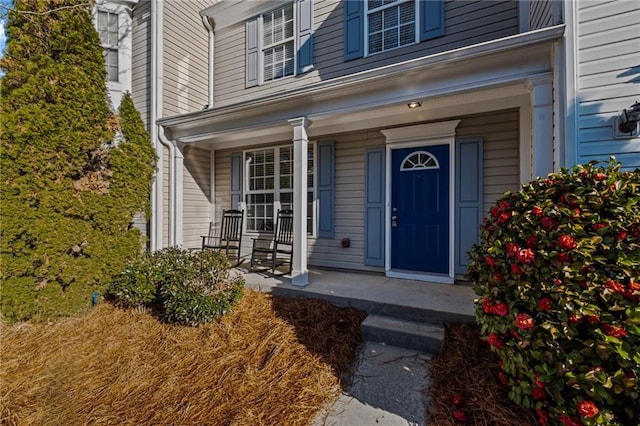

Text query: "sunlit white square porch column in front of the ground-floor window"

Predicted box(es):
[289, 117, 311, 286]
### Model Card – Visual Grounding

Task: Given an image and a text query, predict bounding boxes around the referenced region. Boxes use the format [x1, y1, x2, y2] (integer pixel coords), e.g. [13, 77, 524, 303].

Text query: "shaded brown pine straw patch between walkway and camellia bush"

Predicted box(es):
[428, 324, 537, 426]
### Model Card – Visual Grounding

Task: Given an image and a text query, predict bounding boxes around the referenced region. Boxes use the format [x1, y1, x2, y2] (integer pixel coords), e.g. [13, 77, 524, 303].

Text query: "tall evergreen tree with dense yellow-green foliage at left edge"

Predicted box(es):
[0, 0, 155, 321]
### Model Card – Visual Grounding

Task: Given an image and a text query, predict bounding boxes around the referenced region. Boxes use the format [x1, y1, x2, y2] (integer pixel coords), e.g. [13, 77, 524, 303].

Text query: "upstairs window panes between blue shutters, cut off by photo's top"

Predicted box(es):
[367, 0, 417, 54]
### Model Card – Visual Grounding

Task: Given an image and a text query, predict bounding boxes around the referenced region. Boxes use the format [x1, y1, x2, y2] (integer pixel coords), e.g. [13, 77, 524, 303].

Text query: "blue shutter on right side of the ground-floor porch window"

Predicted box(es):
[317, 141, 335, 238]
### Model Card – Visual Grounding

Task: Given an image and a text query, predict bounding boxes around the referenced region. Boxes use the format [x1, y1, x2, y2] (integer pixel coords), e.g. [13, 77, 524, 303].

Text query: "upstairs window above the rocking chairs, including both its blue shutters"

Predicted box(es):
[245, 0, 313, 87]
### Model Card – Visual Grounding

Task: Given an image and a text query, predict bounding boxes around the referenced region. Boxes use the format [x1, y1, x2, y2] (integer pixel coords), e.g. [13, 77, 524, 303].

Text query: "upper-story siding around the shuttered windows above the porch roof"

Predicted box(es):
[215, 0, 518, 107]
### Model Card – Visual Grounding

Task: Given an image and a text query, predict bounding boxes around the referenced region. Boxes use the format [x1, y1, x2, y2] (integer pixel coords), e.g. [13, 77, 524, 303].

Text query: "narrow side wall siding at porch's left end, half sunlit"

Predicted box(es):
[182, 147, 211, 248]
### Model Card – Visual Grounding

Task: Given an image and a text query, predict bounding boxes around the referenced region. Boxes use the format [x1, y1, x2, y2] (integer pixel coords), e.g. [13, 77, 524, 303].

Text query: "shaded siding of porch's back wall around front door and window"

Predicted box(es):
[208, 110, 519, 271]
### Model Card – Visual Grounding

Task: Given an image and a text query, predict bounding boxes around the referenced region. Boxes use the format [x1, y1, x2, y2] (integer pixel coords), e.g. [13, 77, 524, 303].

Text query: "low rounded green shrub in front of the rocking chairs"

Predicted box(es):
[109, 247, 244, 325]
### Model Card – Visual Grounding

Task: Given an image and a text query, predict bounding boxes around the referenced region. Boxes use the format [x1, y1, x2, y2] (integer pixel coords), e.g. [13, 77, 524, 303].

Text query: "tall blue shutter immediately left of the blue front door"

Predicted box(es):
[364, 148, 386, 266]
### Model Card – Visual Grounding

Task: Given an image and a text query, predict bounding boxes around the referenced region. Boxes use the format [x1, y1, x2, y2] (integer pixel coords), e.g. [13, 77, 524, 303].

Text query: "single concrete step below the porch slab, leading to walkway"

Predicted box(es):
[361, 315, 444, 354]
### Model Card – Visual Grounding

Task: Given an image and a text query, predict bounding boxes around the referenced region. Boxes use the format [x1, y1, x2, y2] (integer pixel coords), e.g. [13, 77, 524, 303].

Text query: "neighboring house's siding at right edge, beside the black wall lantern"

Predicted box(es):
[576, 1, 640, 168]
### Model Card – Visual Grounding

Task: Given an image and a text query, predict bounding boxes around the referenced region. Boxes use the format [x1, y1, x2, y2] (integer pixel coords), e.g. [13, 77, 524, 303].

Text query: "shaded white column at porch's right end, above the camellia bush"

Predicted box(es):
[526, 73, 555, 178]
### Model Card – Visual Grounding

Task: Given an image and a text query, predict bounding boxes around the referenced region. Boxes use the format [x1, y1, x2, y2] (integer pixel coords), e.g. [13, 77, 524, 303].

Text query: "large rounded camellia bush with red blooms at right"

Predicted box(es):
[469, 159, 640, 425]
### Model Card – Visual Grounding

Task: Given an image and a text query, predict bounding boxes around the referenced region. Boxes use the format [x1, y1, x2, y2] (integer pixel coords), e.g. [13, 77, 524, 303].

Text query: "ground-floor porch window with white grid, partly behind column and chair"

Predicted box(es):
[244, 144, 315, 234]
